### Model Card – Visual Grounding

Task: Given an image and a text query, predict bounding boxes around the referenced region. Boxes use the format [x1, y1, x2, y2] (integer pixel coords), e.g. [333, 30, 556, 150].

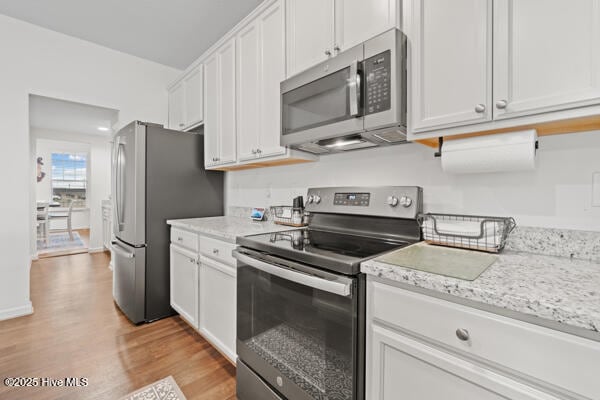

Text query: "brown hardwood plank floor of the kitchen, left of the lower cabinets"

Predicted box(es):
[0, 253, 235, 400]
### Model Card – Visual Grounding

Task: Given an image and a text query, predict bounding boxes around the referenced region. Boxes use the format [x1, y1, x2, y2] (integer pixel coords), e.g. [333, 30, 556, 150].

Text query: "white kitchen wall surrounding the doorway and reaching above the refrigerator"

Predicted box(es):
[0, 15, 180, 319]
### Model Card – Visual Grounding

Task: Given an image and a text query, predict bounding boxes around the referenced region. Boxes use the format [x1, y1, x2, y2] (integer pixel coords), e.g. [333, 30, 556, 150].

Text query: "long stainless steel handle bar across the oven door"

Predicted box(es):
[233, 250, 352, 297]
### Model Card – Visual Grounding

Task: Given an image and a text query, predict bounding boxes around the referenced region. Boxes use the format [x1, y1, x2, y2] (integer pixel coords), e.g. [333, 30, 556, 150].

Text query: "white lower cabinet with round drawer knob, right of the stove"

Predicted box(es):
[366, 277, 600, 400]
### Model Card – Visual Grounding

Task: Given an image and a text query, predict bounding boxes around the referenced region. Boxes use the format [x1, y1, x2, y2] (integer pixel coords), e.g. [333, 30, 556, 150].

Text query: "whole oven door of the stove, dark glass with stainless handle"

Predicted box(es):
[234, 248, 364, 400]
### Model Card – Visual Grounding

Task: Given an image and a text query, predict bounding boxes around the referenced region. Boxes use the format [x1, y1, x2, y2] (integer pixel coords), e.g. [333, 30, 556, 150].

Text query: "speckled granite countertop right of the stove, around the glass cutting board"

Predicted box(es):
[361, 247, 600, 334]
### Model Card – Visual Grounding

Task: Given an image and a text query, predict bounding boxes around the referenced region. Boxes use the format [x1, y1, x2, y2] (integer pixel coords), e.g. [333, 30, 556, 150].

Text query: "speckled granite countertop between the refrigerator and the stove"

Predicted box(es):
[167, 216, 294, 243]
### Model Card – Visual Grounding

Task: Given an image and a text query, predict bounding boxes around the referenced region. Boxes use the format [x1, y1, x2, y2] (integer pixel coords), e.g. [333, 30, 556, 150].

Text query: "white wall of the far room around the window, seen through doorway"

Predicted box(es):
[31, 128, 111, 250]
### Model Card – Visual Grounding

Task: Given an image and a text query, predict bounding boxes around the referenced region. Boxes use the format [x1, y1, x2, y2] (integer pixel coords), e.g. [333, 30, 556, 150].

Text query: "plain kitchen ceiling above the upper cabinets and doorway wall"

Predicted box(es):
[0, 0, 261, 69]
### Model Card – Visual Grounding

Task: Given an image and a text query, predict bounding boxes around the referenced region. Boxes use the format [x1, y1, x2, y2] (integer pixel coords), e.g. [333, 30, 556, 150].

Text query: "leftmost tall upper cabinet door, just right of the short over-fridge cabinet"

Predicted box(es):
[204, 54, 219, 167]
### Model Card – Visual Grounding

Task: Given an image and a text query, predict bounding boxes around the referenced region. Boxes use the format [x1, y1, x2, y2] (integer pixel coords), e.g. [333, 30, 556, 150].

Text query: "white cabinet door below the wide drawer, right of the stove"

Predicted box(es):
[367, 325, 558, 400]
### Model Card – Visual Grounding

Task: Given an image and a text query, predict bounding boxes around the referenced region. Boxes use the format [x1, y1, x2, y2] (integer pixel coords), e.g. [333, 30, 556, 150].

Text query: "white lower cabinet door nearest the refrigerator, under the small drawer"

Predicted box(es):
[170, 244, 198, 328]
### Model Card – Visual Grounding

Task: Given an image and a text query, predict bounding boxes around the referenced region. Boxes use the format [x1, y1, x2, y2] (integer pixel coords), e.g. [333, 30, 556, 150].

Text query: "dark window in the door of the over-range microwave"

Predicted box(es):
[282, 67, 352, 135]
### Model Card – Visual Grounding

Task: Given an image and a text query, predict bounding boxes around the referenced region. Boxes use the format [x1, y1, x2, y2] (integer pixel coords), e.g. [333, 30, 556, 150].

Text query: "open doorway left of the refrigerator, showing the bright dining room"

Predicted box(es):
[29, 95, 118, 259]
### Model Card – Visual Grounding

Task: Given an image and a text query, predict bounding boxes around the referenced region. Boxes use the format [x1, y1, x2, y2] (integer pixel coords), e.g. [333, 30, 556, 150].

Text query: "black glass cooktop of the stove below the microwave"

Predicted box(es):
[238, 229, 410, 274]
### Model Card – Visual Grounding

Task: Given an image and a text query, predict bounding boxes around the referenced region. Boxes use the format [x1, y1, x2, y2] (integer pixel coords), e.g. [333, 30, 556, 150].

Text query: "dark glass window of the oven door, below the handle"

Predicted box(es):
[238, 266, 358, 400]
